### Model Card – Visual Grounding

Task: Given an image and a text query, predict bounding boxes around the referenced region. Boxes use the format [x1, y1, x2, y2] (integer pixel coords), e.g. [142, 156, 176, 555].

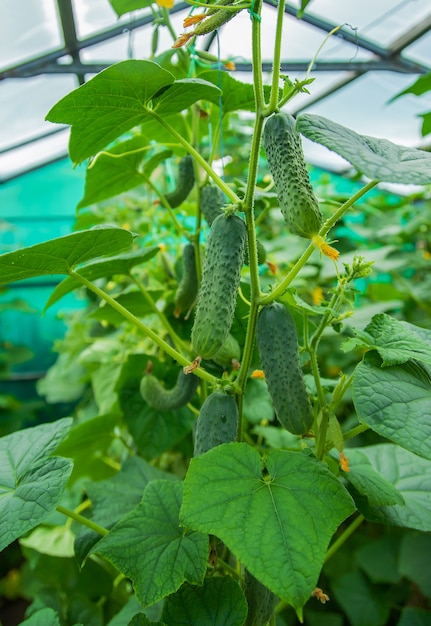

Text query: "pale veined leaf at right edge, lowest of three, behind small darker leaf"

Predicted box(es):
[349, 443, 431, 532]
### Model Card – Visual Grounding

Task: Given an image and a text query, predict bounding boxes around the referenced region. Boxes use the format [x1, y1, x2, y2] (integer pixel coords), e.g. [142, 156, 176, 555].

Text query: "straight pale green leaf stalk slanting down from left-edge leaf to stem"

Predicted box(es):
[69, 270, 217, 385]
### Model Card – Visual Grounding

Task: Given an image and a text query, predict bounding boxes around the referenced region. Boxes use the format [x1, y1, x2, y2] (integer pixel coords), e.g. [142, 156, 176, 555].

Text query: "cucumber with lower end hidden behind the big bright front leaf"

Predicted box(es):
[193, 391, 238, 456]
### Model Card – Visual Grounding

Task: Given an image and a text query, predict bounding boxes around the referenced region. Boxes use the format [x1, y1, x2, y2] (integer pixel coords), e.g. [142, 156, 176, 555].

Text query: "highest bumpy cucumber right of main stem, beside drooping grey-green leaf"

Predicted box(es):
[264, 113, 323, 239]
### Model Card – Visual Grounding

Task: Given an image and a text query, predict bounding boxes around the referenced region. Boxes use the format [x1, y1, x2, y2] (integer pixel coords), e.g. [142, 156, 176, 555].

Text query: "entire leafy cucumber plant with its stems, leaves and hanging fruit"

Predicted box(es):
[0, 0, 431, 626]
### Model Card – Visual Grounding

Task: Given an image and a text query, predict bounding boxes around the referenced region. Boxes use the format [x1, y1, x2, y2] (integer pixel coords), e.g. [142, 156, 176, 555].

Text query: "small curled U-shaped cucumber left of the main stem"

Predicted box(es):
[139, 369, 199, 411]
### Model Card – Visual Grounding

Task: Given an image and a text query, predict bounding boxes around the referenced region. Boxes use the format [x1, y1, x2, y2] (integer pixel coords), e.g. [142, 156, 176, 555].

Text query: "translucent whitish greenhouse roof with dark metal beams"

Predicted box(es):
[0, 0, 431, 181]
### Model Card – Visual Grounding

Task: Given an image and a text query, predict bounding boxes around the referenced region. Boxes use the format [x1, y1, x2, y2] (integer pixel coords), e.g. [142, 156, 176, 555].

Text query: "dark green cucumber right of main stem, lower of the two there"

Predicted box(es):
[256, 302, 313, 435]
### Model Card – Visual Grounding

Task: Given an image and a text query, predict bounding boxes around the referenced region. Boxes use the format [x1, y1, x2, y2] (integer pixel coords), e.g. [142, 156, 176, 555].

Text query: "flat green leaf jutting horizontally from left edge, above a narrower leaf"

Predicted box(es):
[0, 226, 133, 285]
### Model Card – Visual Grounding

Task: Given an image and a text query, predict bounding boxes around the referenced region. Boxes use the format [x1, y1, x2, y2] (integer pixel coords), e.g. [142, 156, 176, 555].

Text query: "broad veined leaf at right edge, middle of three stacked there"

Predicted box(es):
[353, 352, 431, 459]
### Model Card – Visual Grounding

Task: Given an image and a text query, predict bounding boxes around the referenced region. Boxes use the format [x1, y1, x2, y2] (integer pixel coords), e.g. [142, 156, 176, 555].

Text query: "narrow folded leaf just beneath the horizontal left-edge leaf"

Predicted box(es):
[45, 246, 160, 311]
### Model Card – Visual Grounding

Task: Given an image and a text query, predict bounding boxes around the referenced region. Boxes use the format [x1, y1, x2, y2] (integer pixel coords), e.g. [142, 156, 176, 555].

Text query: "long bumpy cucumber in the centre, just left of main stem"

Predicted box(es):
[191, 214, 246, 359]
